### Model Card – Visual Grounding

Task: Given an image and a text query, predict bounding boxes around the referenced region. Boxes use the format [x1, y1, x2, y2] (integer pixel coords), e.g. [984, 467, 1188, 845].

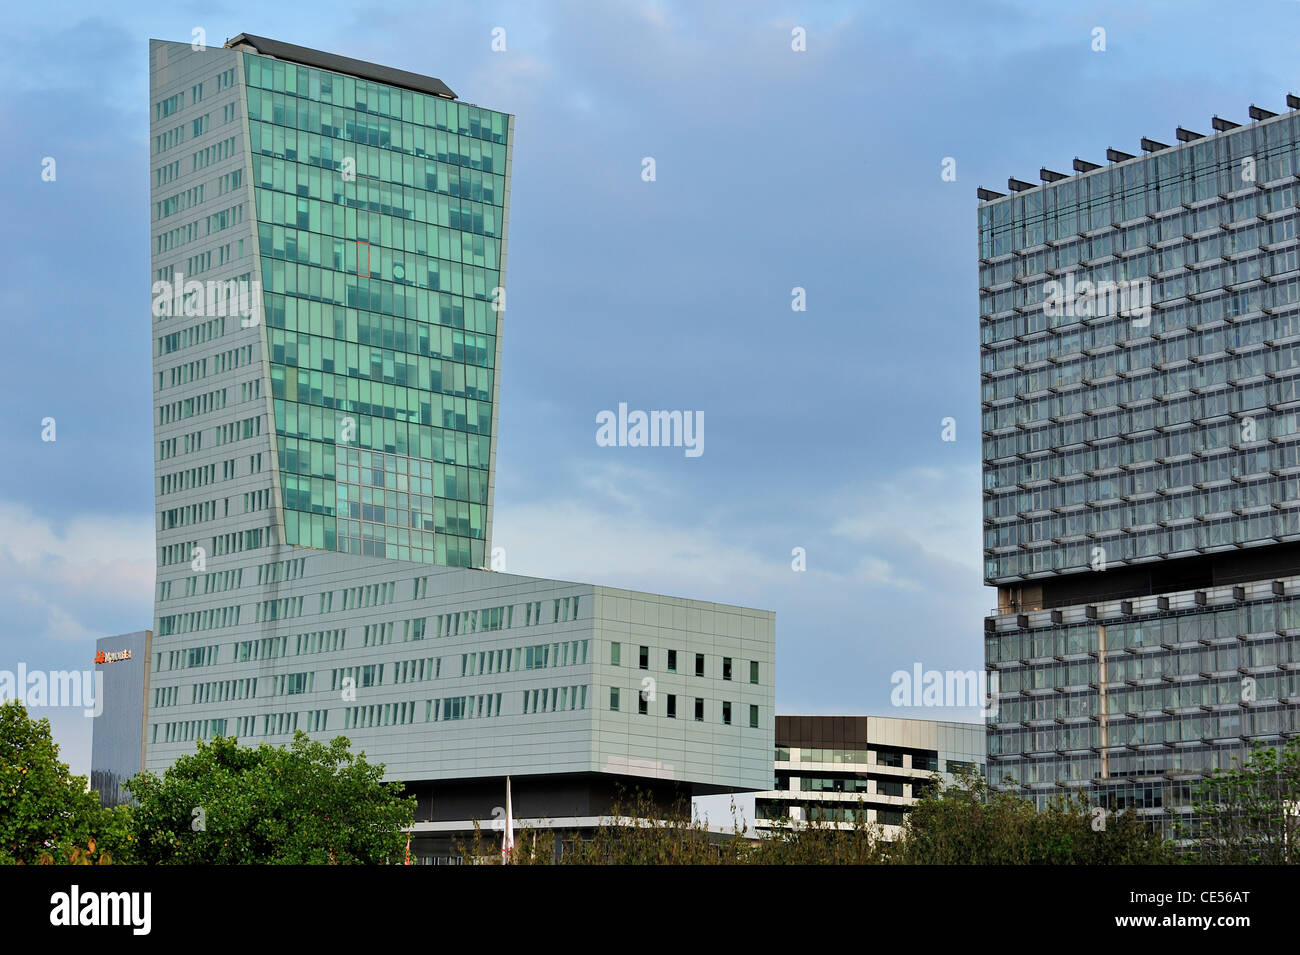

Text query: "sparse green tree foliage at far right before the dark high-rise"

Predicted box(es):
[1190, 738, 1300, 865]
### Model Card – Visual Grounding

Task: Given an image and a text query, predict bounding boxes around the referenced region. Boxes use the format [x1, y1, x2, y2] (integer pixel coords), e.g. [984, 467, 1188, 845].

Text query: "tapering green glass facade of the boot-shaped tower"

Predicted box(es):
[243, 53, 510, 567]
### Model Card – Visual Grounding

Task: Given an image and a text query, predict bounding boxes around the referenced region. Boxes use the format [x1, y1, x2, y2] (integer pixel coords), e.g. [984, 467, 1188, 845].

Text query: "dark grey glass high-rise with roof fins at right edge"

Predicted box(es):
[979, 106, 1300, 830]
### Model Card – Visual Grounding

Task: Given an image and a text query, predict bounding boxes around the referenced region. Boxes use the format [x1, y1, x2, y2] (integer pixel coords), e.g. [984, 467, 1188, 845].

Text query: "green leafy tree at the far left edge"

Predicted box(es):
[0, 700, 131, 865]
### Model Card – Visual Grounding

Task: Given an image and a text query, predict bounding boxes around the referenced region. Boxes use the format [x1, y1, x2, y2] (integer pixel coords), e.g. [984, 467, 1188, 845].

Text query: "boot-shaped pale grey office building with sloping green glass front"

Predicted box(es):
[146, 34, 775, 857]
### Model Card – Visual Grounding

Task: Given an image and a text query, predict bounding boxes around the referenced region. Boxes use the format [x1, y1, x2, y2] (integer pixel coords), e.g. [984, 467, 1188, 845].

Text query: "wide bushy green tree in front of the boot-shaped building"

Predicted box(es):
[126, 730, 416, 865]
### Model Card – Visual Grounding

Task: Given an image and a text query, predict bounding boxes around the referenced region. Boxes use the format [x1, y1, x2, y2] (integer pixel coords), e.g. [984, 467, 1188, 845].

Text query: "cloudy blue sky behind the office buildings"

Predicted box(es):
[0, 0, 1300, 800]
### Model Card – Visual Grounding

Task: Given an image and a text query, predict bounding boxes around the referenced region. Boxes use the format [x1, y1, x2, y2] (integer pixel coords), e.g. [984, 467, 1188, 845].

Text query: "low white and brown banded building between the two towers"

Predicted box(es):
[755, 716, 985, 839]
